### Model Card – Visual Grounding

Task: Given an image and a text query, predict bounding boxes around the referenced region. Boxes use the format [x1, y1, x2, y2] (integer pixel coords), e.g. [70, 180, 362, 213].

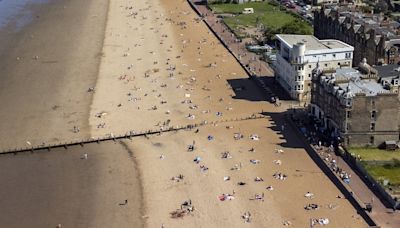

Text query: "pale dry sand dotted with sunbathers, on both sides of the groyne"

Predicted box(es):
[90, 0, 365, 227]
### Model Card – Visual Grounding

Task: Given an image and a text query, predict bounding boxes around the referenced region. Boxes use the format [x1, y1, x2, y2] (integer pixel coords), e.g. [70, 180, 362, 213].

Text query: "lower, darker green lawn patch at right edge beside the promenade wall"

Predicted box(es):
[364, 164, 400, 186]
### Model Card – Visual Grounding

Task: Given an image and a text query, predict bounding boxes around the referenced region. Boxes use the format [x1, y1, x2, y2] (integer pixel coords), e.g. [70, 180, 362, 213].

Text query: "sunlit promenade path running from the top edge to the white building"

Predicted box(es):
[190, 0, 274, 76]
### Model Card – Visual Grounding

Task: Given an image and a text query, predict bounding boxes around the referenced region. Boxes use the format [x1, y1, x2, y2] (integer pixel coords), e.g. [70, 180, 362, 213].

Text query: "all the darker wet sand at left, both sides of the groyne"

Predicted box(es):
[0, 0, 142, 227]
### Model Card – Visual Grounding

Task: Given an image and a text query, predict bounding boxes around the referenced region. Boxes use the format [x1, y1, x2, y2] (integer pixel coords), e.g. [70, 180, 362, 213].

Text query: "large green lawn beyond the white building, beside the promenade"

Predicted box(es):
[209, 2, 313, 37]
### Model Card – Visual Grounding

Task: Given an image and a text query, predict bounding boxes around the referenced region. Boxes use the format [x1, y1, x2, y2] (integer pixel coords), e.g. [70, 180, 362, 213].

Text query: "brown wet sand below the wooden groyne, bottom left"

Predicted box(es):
[0, 142, 142, 228]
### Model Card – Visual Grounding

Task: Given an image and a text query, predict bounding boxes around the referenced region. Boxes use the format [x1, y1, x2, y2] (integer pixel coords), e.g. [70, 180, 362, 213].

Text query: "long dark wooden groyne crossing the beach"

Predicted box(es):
[0, 114, 266, 155]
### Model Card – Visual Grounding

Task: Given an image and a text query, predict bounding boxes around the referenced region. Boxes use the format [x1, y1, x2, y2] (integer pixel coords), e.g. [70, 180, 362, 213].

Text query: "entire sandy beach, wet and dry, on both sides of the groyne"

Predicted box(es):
[0, 0, 366, 227]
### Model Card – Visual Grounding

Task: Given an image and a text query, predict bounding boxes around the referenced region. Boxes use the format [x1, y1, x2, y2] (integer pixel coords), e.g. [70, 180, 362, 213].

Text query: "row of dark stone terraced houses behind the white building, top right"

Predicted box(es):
[314, 7, 400, 65]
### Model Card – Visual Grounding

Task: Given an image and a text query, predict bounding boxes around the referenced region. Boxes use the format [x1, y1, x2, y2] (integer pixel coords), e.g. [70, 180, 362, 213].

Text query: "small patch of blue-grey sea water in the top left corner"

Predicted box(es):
[0, 0, 50, 30]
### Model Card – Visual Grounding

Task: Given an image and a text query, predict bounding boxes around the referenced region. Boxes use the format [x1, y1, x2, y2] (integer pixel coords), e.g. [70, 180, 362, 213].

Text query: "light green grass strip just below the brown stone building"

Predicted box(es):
[348, 148, 400, 161]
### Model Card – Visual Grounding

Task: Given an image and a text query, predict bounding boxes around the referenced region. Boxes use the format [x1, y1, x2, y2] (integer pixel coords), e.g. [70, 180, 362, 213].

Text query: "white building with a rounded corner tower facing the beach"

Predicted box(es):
[274, 34, 354, 102]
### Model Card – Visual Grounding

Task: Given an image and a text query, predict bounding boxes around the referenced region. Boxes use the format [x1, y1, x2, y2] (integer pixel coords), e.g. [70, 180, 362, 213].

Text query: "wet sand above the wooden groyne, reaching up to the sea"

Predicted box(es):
[0, 0, 108, 148]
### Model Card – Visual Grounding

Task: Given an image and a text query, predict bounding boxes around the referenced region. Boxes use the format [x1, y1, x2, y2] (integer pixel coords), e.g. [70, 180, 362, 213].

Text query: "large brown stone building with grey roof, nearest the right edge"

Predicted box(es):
[310, 68, 400, 146]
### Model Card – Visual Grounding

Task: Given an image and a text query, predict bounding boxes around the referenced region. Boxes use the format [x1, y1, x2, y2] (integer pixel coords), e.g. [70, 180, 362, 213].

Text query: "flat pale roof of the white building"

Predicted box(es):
[276, 34, 353, 51]
